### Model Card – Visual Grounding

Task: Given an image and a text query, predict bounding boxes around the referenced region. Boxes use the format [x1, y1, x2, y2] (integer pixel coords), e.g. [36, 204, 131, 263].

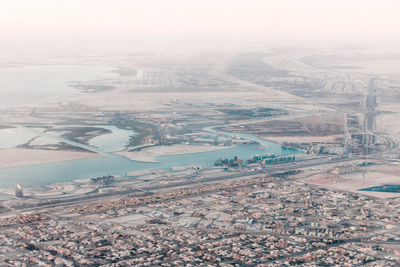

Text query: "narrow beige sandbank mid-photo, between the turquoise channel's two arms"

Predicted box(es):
[115, 144, 228, 162]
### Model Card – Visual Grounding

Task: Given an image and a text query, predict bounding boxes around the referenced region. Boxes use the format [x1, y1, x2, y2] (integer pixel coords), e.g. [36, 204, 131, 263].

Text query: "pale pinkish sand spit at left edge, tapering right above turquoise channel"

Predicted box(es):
[0, 148, 102, 168]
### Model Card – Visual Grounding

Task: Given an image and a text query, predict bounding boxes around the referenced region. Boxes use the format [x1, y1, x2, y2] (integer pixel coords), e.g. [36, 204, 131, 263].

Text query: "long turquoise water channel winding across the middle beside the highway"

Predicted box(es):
[0, 126, 301, 188]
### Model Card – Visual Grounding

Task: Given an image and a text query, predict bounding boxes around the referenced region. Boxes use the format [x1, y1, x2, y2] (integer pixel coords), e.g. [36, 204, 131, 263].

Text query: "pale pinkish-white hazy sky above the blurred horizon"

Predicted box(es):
[0, 0, 400, 55]
